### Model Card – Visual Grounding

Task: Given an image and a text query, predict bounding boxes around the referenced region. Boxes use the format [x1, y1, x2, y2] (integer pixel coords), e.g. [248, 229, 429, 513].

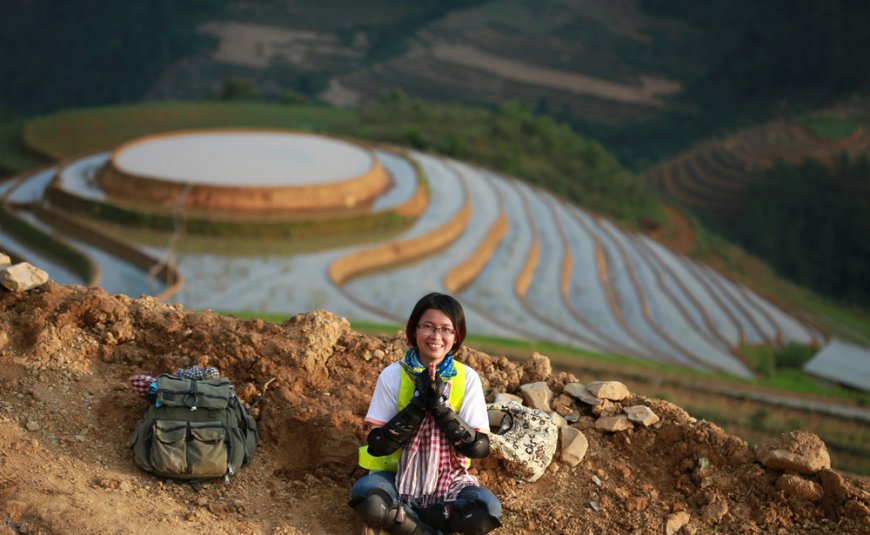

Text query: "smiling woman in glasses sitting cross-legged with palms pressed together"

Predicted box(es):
[350, 293, 501, 535]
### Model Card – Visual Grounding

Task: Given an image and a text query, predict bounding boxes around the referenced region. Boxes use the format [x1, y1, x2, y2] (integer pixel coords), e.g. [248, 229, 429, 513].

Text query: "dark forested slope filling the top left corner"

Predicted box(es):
[0, 0, 228, 114]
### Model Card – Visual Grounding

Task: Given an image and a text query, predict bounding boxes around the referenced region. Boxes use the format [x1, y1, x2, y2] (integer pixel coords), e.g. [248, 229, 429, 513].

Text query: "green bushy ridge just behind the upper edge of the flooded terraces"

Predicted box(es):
[342, 91, 664, 227]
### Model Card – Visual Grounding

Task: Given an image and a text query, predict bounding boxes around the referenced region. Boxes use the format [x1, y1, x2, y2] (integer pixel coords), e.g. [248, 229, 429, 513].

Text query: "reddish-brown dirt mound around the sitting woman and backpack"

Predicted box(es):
[0, 282, 870, 534]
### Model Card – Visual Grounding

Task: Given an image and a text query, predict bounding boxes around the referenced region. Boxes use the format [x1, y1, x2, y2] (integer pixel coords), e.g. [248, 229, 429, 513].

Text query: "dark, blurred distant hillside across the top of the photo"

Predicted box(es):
[0, 0, 870, 168]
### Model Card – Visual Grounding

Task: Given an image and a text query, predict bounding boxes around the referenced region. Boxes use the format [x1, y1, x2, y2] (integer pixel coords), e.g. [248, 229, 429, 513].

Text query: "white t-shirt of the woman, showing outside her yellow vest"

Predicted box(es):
[365, 362, 489, 433]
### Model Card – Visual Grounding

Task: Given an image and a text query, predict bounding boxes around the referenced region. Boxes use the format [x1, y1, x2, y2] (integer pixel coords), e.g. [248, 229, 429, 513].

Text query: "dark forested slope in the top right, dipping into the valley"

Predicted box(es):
[580, 0, 870, 170]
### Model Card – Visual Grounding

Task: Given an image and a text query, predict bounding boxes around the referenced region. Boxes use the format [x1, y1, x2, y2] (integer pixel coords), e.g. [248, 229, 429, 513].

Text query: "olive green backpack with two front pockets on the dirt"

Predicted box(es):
[130, 374, 258, 481]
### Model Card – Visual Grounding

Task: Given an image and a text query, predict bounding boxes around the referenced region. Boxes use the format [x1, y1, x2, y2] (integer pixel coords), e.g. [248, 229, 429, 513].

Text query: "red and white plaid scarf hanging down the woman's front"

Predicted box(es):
[396, 414, 479, 507]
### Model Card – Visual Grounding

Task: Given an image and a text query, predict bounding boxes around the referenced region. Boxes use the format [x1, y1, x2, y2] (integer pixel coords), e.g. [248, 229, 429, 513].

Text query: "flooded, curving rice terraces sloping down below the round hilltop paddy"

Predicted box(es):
[0, 142, 825, 376]
